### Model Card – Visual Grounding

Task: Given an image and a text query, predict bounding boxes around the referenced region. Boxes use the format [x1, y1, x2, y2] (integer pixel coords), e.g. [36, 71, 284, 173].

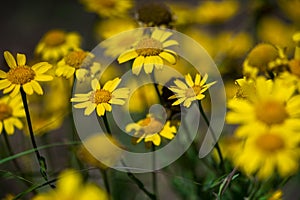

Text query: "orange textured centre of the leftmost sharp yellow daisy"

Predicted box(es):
[7, 65, 35, 85]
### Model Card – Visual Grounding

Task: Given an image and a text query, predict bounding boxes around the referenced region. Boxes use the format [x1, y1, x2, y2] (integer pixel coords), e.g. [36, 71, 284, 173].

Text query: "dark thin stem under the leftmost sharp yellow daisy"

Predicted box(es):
[20, 87, 55, 188]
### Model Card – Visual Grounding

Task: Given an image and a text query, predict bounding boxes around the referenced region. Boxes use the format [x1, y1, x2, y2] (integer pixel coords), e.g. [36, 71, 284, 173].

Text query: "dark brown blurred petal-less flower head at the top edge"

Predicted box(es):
[136, 1, 173, 27]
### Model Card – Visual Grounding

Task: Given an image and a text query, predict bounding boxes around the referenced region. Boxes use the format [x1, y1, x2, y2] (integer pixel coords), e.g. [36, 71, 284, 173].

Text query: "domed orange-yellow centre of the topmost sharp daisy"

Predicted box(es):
[135, 38, 163, 56]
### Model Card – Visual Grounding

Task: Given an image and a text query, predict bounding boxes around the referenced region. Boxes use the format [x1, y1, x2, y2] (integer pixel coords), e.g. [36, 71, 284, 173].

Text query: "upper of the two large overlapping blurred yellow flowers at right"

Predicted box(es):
[226, 77, 300, 132]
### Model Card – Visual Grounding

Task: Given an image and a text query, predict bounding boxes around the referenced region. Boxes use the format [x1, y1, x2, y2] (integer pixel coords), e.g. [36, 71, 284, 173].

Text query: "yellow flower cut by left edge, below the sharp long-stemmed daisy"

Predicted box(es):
[0, 95, 25, 135]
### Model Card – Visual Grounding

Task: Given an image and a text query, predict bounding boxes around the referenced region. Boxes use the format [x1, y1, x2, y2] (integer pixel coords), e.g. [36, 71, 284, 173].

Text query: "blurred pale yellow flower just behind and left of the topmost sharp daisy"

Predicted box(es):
[100, 29, 143, 57]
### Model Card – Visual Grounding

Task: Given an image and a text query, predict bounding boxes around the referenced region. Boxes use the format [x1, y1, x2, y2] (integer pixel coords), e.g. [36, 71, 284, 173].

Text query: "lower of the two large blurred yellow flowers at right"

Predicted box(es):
[233, 124, 300, 179]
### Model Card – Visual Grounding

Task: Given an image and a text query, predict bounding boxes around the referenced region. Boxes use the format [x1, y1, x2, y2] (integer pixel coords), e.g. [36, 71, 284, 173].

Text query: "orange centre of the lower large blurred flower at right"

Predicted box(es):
[255, 133, 284, 153]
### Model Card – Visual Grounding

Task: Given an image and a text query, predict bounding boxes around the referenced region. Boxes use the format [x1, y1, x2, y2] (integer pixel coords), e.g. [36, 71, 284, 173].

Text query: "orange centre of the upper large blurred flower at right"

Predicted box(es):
[255, 100, 289, 125]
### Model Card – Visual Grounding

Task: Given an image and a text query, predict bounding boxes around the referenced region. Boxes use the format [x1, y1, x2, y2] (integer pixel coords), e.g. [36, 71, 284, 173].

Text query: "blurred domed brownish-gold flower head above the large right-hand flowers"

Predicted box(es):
[243, 43, 288, 78]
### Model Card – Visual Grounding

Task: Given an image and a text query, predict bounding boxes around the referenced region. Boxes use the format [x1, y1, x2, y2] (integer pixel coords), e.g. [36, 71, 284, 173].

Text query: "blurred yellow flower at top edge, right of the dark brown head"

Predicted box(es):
[195, 0, 239, 24]
